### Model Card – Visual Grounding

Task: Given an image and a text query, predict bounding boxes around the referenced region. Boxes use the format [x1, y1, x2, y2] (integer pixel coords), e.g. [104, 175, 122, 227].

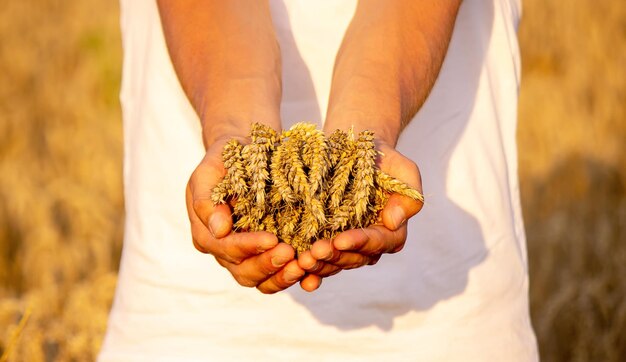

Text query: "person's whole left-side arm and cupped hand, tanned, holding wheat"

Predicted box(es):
[157, 0, 304, 293]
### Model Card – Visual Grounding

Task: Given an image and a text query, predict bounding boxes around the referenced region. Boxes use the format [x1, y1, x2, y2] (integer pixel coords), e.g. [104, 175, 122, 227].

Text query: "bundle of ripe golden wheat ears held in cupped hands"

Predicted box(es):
[212, 123, 424, 253]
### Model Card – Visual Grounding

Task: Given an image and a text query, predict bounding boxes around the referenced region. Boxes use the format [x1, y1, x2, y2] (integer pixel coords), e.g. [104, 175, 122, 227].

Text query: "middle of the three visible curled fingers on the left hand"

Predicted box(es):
[223, 243, 295, 287]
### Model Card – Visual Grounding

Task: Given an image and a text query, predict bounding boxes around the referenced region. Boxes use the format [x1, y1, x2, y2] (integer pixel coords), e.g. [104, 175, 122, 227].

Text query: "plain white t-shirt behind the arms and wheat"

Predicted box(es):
[99, 0, 538, 361]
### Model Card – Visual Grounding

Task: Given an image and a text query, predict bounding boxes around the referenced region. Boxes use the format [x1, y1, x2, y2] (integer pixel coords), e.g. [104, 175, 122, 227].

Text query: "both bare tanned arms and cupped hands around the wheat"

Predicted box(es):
[158, 0, 460, 293]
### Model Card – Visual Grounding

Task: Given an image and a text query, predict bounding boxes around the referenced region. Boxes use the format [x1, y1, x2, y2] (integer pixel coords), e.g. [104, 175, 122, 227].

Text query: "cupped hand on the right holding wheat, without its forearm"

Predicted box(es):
[298, 143, 423, 286]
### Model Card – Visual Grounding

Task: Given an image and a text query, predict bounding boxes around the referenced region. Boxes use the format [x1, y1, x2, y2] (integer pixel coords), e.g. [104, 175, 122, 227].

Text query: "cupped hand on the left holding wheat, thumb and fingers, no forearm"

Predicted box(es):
[186, 140, 305, 294]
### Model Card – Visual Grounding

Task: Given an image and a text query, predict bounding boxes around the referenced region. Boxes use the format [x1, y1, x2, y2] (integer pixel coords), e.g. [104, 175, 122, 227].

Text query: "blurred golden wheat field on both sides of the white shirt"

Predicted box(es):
[0, 0, 626, 361]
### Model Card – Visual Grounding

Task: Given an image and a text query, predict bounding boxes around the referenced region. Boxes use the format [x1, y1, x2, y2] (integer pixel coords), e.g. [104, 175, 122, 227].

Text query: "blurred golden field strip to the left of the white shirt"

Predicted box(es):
[0, 0, 123, 361]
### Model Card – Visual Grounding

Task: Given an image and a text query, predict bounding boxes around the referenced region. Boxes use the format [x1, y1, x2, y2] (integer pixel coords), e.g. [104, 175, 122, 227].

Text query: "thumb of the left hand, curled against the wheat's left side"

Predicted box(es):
[188, 148, 233, 238]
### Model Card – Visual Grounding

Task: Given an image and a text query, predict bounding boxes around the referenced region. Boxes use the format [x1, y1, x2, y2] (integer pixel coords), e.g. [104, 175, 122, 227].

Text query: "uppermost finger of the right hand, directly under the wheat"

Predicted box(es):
[333, 225, 407, 261]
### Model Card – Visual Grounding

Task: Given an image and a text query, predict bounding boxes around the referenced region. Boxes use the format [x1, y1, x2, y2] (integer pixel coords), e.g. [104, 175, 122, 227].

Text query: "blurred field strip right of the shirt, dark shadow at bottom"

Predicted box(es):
[518, 0, 626, 361]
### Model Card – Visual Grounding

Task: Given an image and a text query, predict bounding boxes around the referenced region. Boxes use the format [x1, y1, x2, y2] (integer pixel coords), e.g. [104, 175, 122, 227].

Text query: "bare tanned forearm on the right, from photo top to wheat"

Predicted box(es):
[325, 0, 460, 146]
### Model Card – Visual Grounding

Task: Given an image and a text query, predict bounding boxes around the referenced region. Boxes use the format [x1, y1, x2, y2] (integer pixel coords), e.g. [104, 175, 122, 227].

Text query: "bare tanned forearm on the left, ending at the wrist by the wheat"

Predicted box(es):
[158, 0, 281, 146]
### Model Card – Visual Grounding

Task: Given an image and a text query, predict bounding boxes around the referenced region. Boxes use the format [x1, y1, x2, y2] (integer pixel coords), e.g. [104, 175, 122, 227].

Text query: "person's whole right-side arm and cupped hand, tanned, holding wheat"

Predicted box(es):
[299, 0, 461, 277]
